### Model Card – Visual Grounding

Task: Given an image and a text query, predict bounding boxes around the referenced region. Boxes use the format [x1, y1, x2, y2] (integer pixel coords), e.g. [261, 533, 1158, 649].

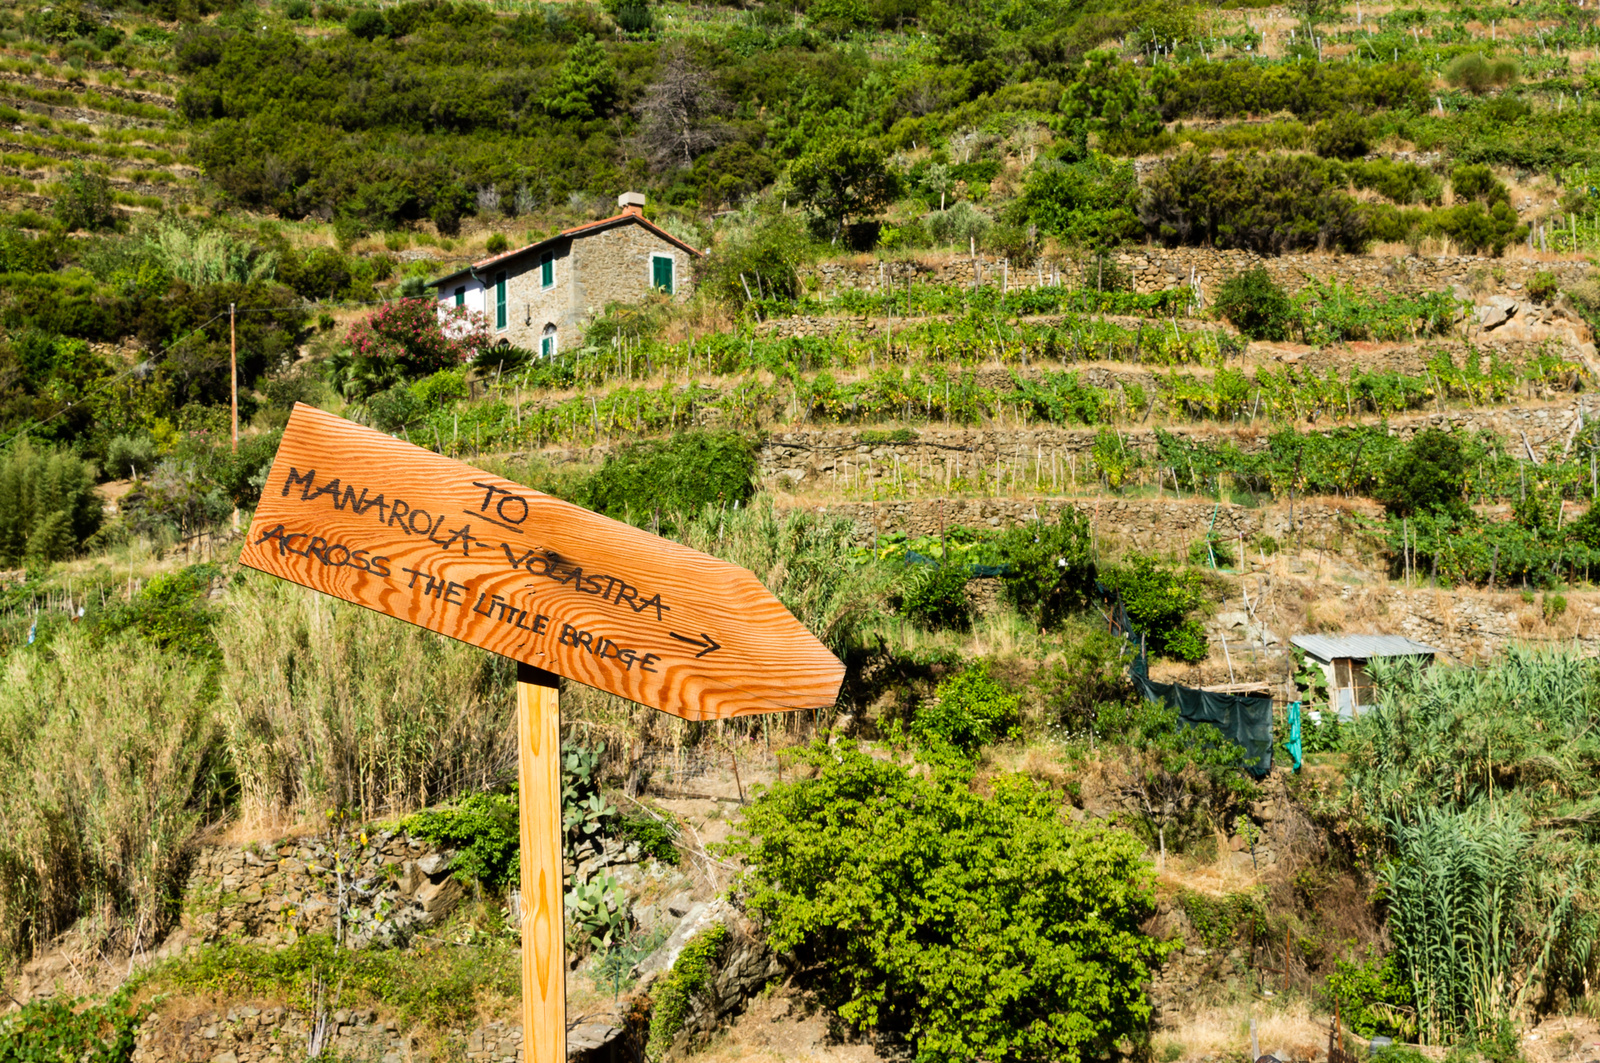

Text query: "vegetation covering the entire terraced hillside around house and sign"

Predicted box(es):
[0, 0, 1600, 1063]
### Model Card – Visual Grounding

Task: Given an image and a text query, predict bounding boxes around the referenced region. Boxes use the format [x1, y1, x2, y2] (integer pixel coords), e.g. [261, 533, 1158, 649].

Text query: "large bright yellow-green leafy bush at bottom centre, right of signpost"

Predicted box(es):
[730, 743, 1171, 1063]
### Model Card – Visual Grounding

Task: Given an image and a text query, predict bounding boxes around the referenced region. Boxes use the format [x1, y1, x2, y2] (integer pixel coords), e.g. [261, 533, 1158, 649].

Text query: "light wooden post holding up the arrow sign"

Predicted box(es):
[517, 664, 566, 1063]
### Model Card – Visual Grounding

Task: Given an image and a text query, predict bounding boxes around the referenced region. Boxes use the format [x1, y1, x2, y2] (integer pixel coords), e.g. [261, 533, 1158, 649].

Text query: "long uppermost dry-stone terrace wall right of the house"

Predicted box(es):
[802, 247, 1590, 298]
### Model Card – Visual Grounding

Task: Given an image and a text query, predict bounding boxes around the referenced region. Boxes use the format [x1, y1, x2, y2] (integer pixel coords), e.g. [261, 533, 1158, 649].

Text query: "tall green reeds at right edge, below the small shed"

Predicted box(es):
[1350, 647, 1600, 1044]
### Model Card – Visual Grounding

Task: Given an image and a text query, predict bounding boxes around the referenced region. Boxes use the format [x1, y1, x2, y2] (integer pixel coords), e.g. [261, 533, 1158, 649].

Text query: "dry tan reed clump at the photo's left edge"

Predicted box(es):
[0, 628, 224, 957]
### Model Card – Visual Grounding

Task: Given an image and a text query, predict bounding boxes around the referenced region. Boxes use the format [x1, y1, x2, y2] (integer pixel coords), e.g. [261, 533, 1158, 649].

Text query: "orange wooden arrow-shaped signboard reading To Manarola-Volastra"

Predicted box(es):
[240, 403, 845, 719]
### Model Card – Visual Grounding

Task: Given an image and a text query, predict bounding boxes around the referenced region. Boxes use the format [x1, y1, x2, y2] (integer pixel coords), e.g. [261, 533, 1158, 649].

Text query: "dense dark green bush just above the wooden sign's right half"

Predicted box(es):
[576, 432, 755, 528]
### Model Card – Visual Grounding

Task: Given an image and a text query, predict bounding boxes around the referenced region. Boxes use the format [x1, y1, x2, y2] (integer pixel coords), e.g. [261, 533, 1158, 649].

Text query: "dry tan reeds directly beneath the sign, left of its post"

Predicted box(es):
[216, 573, 517, 823]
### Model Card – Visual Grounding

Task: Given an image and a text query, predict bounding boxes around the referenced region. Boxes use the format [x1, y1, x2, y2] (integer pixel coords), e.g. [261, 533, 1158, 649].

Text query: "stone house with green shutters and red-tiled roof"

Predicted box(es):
[429, 192, 702, 357]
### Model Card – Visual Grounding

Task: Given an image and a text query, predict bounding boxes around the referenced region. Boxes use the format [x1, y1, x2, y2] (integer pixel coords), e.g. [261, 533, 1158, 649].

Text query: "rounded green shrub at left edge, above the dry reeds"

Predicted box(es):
[0, 437, 104, 568]
